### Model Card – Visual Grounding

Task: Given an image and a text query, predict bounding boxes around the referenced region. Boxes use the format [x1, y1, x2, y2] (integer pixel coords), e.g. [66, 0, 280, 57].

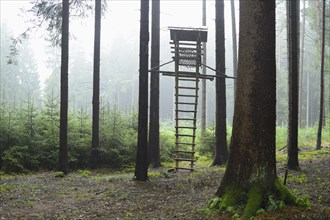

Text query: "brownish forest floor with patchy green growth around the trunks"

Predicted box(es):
[0, 147, 330, 220]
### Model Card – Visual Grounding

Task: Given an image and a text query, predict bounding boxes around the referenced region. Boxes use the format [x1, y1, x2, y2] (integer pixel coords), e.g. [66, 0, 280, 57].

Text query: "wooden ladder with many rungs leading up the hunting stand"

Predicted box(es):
[171, 40, 202, 171]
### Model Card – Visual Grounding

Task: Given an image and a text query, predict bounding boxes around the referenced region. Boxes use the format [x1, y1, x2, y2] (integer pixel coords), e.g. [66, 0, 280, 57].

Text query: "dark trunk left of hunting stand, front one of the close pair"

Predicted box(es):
[135, 0, 149, 181]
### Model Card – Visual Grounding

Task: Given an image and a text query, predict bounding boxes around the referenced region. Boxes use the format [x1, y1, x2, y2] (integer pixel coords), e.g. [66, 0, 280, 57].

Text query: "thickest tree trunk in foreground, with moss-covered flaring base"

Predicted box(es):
[217, 0, 293, 219]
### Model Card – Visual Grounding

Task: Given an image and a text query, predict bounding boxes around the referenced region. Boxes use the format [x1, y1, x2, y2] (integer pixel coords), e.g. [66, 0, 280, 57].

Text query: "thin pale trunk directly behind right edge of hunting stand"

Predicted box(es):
[201, 0, 207, 134]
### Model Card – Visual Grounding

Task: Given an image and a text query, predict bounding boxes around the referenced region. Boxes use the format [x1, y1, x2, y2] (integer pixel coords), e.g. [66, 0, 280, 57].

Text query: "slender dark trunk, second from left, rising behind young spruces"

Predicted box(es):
[91, 0, 101, 168]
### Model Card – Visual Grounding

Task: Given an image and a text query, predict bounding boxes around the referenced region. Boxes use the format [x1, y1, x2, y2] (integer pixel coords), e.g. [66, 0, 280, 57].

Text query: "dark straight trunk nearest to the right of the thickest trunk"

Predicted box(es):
[287, 0, 300, 170]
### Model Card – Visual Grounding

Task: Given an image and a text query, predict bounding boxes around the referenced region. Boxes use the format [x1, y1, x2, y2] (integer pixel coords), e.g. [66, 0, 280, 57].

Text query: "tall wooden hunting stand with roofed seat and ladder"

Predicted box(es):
[150, 27, 229, 171]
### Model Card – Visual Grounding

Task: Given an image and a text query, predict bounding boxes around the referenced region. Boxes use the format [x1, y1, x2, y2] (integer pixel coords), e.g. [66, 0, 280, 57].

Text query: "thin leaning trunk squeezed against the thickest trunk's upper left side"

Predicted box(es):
[230, 0, 237, 99]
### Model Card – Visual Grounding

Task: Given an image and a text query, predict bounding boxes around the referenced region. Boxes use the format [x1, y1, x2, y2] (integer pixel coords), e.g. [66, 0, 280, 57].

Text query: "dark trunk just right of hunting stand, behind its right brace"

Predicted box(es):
[212, 0, 228, 165]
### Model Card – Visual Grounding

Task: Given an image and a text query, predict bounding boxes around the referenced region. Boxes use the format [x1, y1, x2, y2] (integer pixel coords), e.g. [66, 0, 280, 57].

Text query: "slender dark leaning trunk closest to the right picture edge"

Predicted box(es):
[316, 0, 325, 150]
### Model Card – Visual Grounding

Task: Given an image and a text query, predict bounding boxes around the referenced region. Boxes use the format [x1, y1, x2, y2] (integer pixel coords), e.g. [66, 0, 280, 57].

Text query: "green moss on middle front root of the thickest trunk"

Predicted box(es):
[242, 185, 263, 219]
